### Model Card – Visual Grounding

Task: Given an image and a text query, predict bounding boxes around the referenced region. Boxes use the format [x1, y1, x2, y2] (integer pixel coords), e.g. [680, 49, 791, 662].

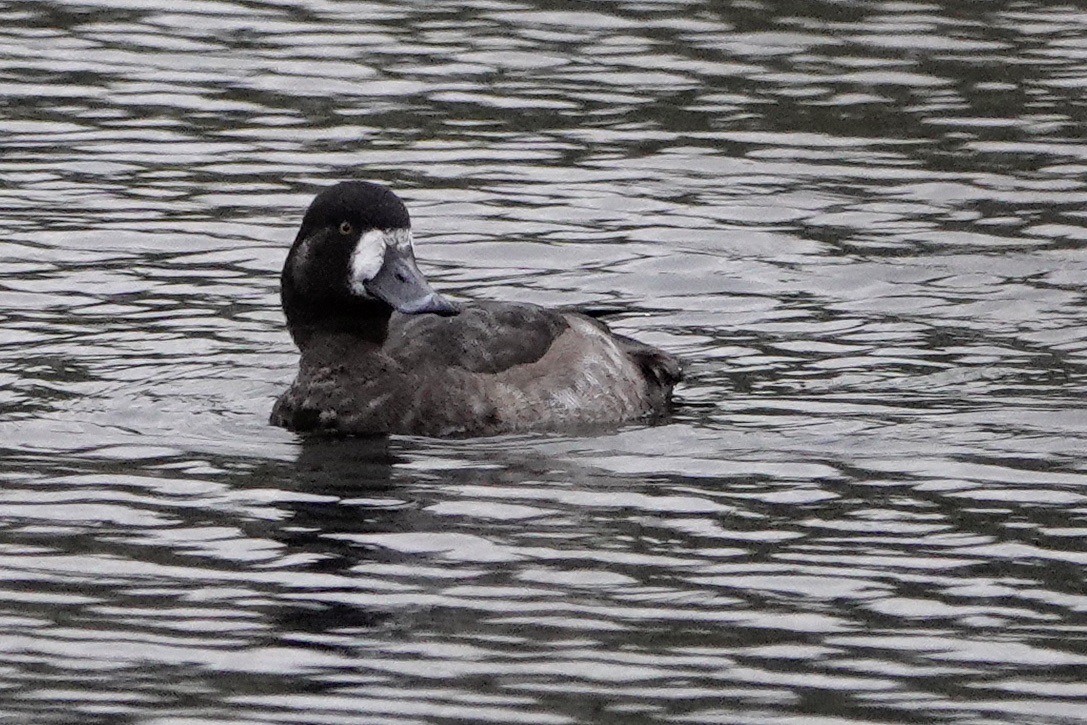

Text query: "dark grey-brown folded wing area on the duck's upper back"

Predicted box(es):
[383, 302, 569, 373]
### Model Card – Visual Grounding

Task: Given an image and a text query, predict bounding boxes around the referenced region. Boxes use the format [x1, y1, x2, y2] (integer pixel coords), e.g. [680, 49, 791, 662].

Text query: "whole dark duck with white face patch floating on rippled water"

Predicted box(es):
[271, 180, 683, 438]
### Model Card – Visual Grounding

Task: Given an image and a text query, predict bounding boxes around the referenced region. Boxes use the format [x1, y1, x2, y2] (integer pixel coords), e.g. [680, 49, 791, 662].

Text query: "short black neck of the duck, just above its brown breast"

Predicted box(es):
[283, 293, 392, 350]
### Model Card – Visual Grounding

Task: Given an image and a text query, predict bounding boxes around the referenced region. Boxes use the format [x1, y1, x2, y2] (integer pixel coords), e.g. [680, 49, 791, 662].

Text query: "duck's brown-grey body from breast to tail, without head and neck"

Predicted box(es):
[272, 302, 680, 436]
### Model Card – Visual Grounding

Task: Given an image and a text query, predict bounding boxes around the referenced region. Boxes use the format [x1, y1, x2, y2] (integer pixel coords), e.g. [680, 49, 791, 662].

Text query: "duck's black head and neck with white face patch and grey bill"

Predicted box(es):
[282, 182, 457, 346]
